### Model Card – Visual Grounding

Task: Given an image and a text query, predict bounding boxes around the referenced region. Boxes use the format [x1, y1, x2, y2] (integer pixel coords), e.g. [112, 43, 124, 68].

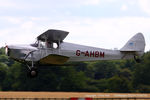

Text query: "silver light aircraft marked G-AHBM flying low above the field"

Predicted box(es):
[5, 29, 145, 77]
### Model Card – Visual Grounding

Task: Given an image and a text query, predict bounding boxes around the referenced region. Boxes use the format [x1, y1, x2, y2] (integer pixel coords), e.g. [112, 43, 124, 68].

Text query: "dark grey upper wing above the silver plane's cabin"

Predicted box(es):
[37, 29, 69, 42]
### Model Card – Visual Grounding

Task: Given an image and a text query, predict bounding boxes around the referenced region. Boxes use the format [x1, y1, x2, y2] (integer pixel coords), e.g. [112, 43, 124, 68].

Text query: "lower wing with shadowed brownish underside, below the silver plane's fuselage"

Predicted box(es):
[39, 54, 69, 65]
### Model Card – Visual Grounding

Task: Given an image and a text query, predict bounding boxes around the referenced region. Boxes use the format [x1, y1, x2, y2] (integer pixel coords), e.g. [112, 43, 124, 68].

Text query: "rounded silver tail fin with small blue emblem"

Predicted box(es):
[120, 33, 145, 55]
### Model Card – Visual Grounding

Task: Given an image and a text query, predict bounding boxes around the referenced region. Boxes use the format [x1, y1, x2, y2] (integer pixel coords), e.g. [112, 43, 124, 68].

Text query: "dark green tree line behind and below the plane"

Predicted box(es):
[0, 48, 150, 93]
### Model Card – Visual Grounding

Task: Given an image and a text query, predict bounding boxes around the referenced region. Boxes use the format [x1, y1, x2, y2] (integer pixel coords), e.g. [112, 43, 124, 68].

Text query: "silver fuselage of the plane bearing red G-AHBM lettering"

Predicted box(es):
[6, 42, 134, 64]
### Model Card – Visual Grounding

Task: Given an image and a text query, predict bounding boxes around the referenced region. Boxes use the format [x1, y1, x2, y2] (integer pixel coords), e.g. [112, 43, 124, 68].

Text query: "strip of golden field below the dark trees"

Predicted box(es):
[0, 92, 150, 98]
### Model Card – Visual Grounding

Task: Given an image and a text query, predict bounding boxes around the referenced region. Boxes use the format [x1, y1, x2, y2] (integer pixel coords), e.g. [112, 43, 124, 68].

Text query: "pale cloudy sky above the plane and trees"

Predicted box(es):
[0, 0, 150, 51]
